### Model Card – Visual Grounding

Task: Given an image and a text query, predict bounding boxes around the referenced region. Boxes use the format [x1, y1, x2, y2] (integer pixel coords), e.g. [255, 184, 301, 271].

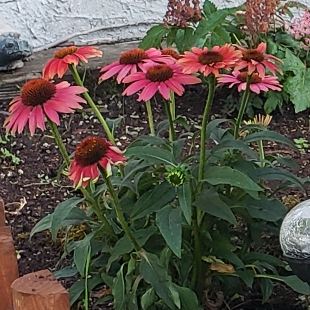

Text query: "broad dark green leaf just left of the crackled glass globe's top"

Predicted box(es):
[243, 195, 287, 222]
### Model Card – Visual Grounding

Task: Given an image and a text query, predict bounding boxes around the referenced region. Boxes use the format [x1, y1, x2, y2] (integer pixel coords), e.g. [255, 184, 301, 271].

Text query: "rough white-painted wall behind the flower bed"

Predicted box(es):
[0, 0, 310, 48]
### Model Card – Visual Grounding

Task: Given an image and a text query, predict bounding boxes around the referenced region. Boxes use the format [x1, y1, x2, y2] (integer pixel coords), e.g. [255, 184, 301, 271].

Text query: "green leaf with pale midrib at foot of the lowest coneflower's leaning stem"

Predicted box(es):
[139, 251, 176, 310]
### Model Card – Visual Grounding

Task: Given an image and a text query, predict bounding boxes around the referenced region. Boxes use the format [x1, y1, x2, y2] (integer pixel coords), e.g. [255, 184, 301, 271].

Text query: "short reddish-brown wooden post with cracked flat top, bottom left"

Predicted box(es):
[12, 270, 70, 310]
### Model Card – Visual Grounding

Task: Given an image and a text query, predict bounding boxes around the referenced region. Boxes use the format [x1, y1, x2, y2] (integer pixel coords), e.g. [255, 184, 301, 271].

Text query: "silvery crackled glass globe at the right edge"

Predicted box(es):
[280, 199, 310, 259]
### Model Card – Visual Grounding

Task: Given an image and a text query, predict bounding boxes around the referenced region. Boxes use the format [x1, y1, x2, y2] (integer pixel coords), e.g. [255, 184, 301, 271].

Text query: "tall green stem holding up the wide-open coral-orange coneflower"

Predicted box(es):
[198, 74, 215, 186]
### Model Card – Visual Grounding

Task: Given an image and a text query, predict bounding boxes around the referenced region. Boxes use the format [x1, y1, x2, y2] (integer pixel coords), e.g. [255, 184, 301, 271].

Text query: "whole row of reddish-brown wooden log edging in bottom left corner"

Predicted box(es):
[0, 197, 70, 310]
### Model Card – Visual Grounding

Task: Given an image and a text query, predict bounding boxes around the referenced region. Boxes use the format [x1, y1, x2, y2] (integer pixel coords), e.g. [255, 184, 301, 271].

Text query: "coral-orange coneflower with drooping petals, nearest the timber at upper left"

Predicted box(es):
[42, 46, 102, 80]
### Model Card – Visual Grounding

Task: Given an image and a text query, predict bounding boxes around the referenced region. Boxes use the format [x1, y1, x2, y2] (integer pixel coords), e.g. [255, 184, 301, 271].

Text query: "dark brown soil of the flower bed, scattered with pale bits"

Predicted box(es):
[0, 80, 310, 310]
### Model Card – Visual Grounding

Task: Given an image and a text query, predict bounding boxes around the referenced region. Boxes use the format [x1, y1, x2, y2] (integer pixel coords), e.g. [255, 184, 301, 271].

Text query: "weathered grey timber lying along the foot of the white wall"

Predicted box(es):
[0, 41, 139, 102]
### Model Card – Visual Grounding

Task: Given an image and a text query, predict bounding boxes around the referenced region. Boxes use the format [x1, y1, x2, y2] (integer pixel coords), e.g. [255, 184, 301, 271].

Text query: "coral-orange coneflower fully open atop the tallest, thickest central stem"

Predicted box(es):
[177, 44, 241, 76]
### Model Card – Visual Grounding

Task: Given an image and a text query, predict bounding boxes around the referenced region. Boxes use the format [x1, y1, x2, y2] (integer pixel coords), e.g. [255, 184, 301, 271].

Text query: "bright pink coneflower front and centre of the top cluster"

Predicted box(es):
[123, 64, 201, 101]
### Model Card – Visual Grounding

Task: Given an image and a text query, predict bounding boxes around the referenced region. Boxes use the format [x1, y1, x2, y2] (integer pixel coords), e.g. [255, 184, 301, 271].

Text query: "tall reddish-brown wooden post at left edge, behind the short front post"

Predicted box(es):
[0, 226, 19, 310]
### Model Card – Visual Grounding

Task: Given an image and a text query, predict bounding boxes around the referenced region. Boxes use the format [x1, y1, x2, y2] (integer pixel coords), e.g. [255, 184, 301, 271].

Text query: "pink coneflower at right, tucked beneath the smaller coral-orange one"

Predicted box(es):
[218, 71, 282, 94]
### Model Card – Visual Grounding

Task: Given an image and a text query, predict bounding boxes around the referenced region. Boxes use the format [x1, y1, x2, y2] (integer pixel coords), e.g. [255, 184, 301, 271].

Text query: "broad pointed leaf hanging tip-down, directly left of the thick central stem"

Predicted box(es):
[156, 205, 182, 258]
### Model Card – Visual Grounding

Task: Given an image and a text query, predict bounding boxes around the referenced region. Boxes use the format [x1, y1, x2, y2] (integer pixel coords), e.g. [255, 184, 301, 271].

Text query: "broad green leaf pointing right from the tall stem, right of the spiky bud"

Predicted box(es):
[204, 166, 263, 191]
